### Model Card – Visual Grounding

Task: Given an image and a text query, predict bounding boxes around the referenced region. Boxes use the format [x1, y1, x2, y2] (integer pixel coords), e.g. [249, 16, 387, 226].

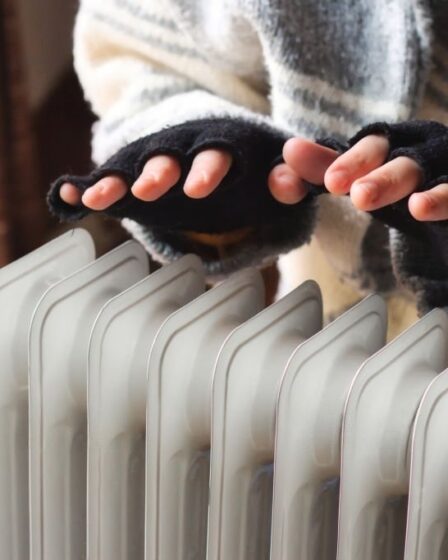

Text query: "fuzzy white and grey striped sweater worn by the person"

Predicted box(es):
[47, 0, 448, 322]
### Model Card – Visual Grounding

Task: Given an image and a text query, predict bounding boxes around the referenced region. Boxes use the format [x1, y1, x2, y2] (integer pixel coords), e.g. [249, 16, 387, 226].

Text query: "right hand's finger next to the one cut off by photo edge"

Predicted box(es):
[350, 157, 422, 211]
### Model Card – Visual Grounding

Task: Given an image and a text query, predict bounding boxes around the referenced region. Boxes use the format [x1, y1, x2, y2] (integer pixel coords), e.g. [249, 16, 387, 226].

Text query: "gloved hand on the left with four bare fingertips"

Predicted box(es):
[47, 117, 316, 245]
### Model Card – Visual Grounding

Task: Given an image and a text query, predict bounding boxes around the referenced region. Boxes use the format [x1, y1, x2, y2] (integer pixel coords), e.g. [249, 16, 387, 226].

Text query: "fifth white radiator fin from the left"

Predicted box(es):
[208, 282, 322, 560]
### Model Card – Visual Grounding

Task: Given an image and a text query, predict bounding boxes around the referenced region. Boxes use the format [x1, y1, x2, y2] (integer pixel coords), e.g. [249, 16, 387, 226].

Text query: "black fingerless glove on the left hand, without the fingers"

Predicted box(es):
[48, 117, 315, 274]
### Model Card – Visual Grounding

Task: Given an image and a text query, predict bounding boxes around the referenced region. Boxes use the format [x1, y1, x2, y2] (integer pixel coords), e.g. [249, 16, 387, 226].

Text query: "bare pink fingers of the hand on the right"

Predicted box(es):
[269, 135, 448, 221]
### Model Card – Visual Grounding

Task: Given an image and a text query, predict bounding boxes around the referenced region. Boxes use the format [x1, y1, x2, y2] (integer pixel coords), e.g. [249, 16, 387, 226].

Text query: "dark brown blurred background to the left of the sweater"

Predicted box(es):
[0, 0, 125, 266]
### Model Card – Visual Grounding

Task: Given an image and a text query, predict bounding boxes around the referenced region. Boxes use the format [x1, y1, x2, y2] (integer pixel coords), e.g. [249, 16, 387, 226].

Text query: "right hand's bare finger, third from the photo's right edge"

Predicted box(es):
[325, 135, 389, 195]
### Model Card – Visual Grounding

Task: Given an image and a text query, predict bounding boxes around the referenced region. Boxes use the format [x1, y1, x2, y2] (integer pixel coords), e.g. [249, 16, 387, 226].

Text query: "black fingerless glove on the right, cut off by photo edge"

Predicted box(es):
[321, 121, 448, 313]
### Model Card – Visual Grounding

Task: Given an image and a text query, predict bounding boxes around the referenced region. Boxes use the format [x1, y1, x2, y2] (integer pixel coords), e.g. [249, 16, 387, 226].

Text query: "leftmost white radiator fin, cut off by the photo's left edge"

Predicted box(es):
[0, 229, 94, 560]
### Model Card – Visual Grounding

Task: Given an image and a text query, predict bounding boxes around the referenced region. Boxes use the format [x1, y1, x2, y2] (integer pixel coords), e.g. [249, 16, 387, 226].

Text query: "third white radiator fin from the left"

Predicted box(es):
[88, 255, 205, 560]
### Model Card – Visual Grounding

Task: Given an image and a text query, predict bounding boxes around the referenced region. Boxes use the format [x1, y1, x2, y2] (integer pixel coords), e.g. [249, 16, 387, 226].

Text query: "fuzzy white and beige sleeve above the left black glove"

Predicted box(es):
[74, 0, 269, 164]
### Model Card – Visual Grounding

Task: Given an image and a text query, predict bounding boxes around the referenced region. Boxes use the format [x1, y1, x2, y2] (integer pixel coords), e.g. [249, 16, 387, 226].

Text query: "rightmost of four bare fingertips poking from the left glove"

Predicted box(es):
[184, 150, 232, 198]
